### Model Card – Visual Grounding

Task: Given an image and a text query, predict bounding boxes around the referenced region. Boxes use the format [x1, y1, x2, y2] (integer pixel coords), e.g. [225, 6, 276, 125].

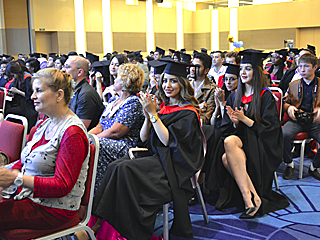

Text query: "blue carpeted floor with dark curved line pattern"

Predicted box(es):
[155, 158, 320, 240]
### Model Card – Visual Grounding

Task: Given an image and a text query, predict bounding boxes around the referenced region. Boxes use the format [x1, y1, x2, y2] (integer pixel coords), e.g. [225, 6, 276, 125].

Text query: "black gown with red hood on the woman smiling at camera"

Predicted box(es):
[93, 106, 204, 240]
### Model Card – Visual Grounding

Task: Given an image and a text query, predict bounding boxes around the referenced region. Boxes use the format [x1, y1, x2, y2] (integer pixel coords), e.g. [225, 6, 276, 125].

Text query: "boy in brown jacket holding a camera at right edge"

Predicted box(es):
[282, 53, 320, 180]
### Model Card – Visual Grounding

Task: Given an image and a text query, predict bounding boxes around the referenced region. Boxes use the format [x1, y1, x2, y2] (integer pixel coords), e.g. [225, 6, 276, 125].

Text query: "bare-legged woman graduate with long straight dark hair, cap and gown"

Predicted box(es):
[208, 50, 289, 218]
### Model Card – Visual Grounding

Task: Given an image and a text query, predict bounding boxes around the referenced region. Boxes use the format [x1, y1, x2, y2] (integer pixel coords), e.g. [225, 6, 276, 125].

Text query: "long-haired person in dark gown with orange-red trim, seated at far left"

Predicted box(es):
[5, 61, 38, 132]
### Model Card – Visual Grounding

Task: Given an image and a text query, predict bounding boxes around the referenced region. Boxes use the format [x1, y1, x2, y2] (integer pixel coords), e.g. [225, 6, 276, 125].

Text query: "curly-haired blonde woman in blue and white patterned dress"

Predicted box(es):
[90, 63, 144, 191]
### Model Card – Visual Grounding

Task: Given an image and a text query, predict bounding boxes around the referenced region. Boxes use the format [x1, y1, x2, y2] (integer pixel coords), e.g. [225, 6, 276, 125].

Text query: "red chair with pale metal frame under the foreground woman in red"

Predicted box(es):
[2, 133, 100, 240]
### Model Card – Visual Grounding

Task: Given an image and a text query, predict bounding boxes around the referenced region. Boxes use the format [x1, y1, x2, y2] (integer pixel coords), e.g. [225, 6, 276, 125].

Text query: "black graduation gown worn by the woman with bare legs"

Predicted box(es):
[207, 90, 289, 215]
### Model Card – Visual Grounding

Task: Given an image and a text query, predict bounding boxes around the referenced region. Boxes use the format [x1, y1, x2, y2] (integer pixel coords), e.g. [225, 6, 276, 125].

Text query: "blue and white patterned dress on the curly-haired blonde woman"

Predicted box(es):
[95, 95, 144, 192]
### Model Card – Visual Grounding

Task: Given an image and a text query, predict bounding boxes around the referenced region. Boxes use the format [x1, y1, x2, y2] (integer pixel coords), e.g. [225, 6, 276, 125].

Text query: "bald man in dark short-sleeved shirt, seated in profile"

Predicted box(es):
[64, 56, 104, 131]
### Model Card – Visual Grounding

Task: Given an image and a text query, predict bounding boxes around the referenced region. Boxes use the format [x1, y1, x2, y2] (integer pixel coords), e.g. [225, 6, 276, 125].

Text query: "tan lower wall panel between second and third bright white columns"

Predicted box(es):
[112, 32, 147, 52]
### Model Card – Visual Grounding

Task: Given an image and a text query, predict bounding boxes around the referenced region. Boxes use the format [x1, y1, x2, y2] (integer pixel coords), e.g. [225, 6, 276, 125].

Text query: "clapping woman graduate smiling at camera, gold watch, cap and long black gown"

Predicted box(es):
[82, 62, 204, 240]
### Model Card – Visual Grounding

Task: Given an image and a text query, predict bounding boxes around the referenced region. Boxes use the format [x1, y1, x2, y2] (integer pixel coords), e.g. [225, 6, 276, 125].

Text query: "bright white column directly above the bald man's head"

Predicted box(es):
[74, 0, 86, 54]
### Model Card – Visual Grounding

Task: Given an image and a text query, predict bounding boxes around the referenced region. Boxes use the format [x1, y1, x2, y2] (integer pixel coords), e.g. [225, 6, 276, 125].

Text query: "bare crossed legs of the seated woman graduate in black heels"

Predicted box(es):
[222, 135, 261, 215]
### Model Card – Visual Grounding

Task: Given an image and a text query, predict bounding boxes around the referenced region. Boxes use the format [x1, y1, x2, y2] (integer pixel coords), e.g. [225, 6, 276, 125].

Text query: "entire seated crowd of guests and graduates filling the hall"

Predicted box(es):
[0, 45, 320, 240]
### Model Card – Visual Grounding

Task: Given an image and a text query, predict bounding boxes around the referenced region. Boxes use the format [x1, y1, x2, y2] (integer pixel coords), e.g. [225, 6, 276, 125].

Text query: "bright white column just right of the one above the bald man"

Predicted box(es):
[102, 0, 113, 54]
